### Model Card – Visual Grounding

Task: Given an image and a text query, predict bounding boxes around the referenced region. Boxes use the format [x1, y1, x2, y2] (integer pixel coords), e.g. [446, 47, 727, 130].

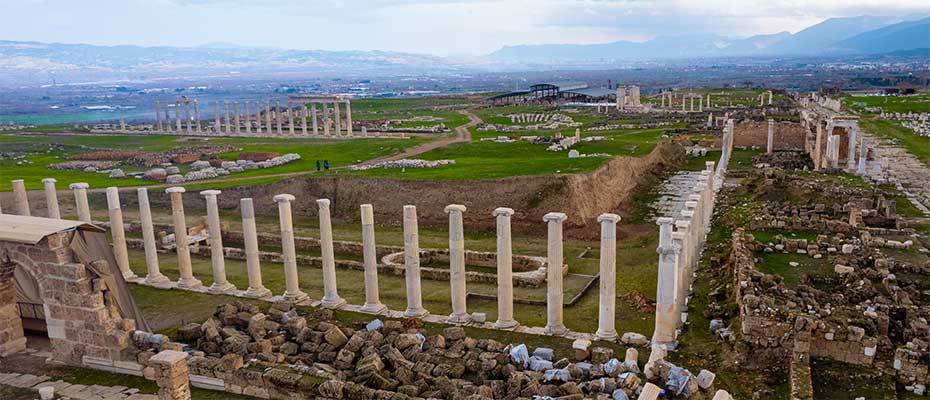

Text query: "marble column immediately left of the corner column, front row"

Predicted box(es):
[595, 214, 620, 341]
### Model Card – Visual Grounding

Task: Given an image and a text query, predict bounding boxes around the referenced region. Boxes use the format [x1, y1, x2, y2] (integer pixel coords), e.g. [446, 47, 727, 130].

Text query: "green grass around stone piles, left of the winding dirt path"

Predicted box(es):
[0, 135, 430, 191]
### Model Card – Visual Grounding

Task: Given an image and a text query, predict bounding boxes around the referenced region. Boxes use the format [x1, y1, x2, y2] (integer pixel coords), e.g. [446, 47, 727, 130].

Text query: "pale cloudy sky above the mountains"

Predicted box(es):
[0, 0, 930, 55]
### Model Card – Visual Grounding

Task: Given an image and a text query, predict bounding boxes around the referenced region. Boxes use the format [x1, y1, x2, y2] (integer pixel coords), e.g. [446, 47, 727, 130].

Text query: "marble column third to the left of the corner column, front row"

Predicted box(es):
[493, 207, 518, 329]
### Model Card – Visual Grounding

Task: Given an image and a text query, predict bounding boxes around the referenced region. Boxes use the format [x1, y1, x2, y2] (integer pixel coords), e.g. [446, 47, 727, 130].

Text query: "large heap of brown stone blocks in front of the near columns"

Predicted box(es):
[134, 301, 730, 400]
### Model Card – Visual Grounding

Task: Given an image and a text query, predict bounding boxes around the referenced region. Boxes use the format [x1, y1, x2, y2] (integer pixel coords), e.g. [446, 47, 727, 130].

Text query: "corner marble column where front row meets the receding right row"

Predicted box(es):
[652, 217, 681, 345]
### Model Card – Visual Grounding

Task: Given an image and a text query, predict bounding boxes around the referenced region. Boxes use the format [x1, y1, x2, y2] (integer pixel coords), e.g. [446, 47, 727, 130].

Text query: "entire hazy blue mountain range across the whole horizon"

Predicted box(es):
[0, 16, 930, 87]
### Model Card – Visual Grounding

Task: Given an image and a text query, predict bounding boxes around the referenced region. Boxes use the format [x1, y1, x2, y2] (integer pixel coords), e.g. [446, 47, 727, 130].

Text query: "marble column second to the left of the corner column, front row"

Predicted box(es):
[543, 212, 568, 335]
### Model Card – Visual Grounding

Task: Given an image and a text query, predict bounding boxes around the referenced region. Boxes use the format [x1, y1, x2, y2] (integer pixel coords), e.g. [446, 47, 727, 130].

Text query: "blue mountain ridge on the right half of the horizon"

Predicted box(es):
[490, 16, 930, 62]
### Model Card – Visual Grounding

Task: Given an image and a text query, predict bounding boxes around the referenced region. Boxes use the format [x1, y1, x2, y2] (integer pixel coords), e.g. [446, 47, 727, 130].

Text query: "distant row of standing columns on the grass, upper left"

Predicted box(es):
[150, 99, 353, 136]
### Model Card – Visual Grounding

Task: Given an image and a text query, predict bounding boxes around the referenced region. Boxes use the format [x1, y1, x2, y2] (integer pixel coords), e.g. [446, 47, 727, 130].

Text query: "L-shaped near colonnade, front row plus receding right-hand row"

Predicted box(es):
[0, 159, 726, 344]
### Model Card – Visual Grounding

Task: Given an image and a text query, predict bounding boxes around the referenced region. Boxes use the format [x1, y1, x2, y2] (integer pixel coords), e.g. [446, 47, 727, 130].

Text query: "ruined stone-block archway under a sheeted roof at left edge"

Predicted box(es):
[0, 219, 135, 365]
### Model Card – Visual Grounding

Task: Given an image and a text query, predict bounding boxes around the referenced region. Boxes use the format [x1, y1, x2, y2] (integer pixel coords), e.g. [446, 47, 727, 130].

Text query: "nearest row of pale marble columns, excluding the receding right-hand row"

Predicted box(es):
[14, 180, 632, 340]
